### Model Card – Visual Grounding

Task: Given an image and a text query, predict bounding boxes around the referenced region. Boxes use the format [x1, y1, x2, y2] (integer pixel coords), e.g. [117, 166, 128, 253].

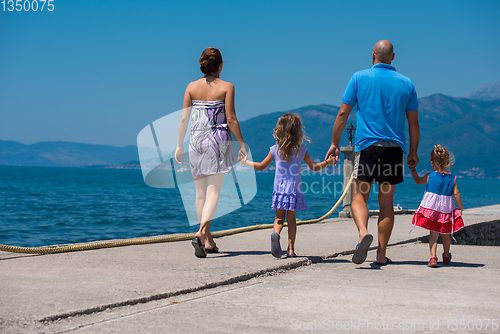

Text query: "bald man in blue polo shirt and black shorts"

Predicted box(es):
[326, 40, 420, 265]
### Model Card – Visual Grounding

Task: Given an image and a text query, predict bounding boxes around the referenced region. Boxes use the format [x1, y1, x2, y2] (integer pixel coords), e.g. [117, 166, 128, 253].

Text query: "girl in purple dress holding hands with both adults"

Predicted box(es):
[242, 113, 333, 258]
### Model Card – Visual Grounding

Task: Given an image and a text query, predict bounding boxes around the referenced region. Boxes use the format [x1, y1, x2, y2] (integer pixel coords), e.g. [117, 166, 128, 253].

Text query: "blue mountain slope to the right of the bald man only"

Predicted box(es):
[419, 94, 500, 177]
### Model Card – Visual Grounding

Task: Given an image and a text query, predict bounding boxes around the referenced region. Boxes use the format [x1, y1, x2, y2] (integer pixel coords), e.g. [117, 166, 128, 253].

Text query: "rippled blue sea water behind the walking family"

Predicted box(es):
[0, 166, 500, 247]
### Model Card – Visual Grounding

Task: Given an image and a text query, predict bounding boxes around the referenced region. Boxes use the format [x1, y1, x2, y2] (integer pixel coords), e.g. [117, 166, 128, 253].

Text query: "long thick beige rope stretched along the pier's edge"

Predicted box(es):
[0, 175, 354, 254]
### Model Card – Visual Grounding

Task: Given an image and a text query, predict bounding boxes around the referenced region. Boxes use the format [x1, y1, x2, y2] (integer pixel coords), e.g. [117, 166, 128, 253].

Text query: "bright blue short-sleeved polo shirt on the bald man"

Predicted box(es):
[342, 63, 418, 152]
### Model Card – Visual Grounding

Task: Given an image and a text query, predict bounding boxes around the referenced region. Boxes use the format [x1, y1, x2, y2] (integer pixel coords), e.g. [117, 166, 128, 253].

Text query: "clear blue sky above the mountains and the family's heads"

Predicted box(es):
[0, 0, 500, 146]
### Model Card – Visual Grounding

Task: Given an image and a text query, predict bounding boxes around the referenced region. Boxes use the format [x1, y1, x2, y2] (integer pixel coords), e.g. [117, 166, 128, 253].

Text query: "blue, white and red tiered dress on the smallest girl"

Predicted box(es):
[412, 172, 464, 234]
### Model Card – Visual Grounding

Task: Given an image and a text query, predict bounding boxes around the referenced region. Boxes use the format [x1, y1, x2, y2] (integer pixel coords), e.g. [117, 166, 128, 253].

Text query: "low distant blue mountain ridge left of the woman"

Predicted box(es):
[0, 141, 138, 167]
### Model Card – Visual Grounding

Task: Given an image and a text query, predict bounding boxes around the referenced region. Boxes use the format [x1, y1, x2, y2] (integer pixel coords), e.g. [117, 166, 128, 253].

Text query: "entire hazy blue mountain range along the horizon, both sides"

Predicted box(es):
[0, 81, 500, 178]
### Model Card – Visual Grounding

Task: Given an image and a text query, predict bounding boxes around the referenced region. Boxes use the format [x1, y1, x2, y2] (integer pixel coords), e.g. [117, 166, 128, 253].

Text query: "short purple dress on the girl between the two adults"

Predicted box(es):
[270, 145, 308, 211]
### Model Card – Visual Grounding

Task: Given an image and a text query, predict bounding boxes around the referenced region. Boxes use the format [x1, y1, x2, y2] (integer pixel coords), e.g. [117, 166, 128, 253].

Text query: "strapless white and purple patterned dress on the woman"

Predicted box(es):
[189, 100, 234, 179]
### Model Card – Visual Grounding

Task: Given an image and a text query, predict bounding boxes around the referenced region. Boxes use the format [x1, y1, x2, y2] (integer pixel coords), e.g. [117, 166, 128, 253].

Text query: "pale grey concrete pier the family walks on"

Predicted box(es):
[0, 205, 500, 333]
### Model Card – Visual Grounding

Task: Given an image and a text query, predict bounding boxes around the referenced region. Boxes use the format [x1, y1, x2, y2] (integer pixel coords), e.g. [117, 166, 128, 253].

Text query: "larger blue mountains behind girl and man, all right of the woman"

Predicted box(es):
[240, 94, 500, 178]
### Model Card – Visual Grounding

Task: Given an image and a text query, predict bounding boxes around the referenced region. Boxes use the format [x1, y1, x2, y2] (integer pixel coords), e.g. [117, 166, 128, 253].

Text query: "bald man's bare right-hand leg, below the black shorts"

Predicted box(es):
[377, 183, 396, 263]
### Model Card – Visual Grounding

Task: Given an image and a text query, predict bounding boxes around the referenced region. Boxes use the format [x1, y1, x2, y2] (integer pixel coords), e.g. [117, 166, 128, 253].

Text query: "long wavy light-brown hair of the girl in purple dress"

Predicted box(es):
[273, 113, 309, 161]
